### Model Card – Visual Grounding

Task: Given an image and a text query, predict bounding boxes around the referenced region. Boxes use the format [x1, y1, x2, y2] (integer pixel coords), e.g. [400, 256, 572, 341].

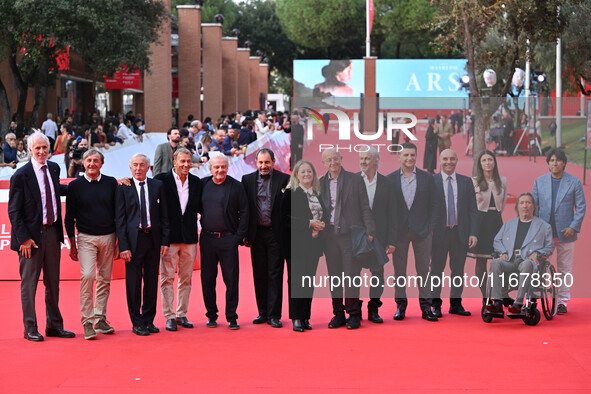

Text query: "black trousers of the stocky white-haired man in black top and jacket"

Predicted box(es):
[199, 232, 239, 321]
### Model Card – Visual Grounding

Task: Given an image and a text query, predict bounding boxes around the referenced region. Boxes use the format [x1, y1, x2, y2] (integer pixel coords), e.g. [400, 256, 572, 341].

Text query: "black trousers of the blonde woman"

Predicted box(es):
[287, 257, 319, 319]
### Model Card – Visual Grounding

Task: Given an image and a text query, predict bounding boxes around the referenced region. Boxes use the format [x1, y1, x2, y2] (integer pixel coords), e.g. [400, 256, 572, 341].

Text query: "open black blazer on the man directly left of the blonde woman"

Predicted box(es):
[242, 170, 289, 245]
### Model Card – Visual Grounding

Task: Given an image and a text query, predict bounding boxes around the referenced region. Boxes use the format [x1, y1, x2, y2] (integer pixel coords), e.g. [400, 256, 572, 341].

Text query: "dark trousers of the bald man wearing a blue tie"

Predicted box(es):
[431, 226, 468, 307]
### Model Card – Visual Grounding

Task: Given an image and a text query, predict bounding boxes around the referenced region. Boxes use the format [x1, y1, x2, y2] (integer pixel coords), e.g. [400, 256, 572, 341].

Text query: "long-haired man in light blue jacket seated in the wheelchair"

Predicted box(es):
[486, 193, 553, 313]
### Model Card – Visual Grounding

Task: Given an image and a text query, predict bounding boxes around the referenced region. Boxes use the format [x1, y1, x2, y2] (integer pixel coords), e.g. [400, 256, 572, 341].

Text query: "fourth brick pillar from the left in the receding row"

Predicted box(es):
[222, 37, 238, 114]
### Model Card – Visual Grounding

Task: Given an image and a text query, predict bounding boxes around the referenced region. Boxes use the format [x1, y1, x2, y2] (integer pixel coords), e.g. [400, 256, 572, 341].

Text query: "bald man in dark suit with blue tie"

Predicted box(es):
[431, 149, 478, 317]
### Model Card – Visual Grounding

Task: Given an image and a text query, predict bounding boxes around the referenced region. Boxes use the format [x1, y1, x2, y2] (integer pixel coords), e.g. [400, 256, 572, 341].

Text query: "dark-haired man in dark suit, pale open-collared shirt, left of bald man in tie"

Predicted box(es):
[388, 142, 438, 321]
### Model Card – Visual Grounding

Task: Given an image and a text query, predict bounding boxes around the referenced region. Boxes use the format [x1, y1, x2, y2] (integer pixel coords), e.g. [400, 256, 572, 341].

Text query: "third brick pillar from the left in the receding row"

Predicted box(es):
[201, 23, 222, 121]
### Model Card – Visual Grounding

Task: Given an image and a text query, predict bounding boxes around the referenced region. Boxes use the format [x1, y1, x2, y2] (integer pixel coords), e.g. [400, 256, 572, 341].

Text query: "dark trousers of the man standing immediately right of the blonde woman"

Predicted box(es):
[324, 231, 361, 316]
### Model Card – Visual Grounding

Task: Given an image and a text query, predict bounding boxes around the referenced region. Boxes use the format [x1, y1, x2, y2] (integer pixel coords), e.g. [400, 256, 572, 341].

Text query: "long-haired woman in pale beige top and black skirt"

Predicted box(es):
[468, 150, 507, 302]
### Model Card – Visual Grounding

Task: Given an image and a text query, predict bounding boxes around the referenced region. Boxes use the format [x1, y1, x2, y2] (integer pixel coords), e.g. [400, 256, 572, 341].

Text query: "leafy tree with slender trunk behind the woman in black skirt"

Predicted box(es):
[433, 0, 566, 165]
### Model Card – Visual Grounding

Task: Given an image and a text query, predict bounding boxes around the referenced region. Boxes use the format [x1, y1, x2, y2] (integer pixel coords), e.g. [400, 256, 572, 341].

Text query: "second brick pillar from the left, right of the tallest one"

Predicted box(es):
[176, 5, 201, 124]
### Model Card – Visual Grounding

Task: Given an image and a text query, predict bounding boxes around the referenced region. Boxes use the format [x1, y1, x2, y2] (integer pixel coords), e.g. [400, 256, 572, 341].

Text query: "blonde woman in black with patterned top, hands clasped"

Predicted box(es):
[281, 160, 330, 332]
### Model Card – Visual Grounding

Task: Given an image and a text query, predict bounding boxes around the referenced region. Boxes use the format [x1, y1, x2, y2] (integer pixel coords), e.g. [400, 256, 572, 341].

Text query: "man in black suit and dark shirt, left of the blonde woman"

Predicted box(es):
[242, 148, 289, 328]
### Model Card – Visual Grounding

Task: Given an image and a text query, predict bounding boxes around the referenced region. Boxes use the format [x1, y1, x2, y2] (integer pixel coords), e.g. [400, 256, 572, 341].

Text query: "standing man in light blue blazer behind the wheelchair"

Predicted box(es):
[532, 149, 586, 315]
